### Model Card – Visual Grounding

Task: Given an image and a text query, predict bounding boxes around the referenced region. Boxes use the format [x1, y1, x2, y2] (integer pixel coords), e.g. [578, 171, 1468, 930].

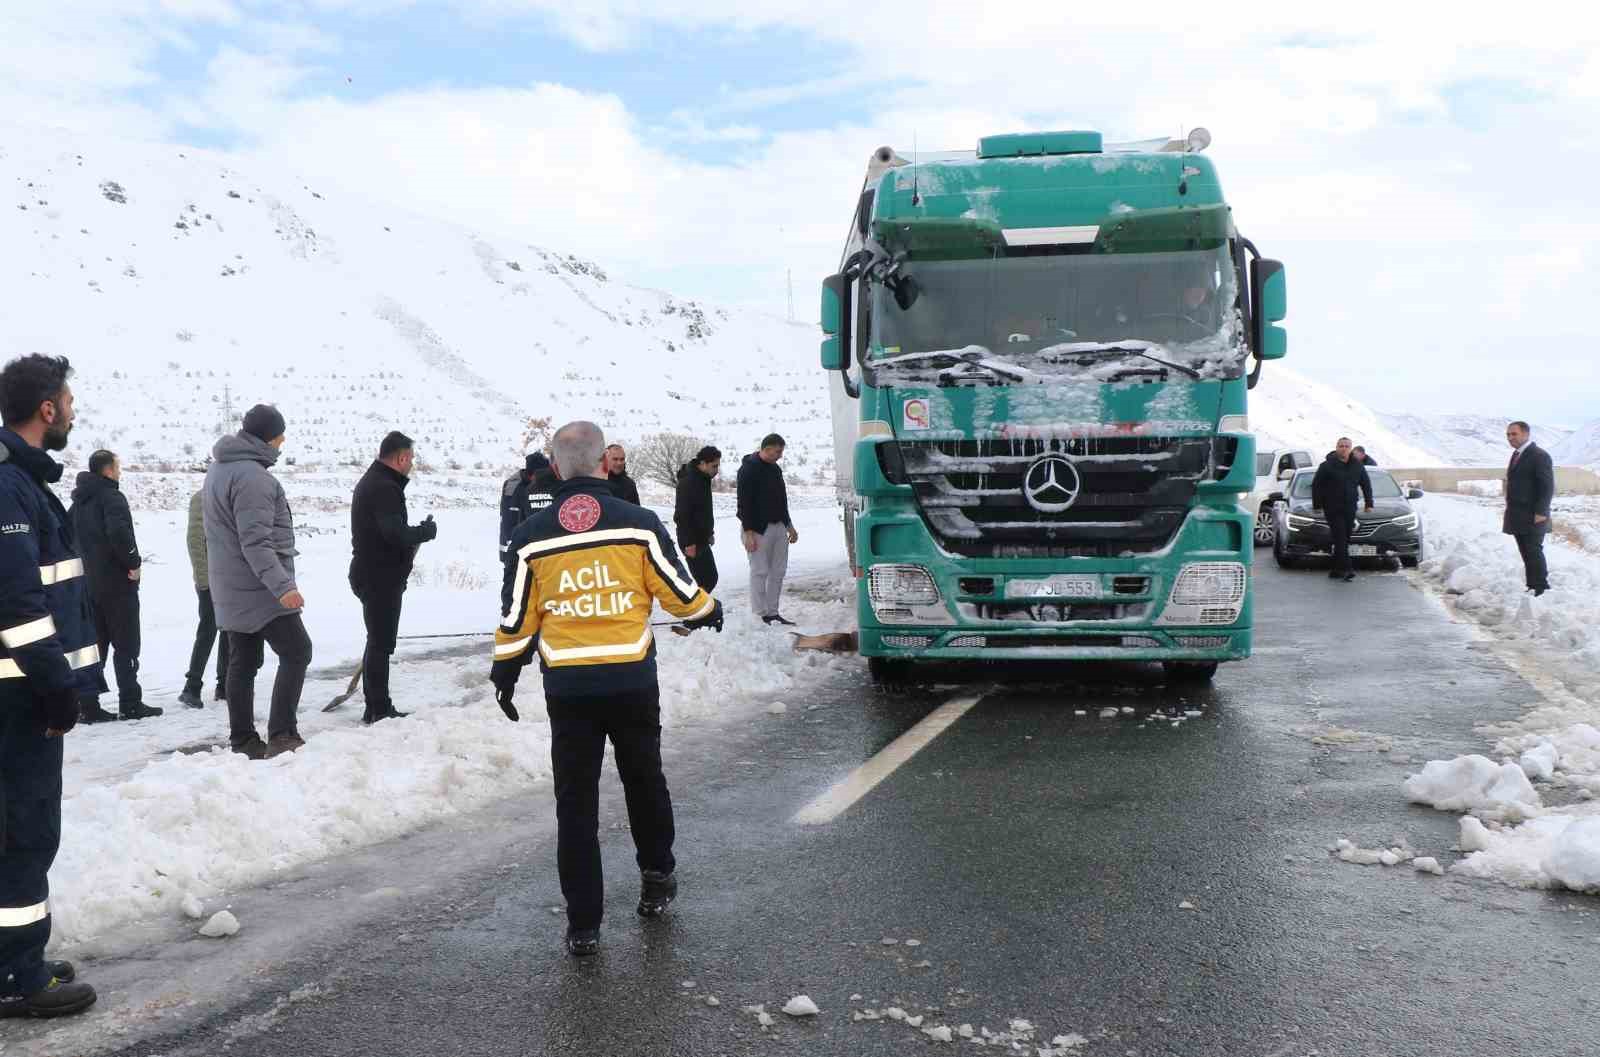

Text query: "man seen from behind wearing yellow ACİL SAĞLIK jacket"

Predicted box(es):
[490, 422, 722, 956]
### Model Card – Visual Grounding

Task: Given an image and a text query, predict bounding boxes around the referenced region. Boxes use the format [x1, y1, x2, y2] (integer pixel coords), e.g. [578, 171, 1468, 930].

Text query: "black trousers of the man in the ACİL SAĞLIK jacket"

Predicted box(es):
[546, 686, 677, 929]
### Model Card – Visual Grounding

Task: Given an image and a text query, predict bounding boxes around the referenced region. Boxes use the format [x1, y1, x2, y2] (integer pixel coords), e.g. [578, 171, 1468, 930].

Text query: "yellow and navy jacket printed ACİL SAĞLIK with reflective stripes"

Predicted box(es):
[494, 477, 712, 696]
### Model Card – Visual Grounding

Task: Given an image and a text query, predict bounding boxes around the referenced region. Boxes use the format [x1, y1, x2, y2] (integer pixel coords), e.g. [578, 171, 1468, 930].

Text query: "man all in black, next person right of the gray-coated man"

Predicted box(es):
[350, 432, 438, 723]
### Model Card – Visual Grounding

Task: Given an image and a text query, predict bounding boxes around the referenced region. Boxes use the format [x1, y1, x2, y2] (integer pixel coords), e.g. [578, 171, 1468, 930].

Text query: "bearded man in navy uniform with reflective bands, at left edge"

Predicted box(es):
[0, 355, 102, 1017]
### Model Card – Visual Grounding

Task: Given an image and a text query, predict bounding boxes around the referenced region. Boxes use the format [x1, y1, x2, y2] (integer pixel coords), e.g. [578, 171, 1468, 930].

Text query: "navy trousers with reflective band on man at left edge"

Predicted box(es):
[0, 694, 66, 996]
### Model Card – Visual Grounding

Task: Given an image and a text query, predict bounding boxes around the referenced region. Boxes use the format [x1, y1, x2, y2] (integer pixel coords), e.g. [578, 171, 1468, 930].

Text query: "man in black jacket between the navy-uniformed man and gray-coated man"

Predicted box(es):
[72, 449, 162, 723]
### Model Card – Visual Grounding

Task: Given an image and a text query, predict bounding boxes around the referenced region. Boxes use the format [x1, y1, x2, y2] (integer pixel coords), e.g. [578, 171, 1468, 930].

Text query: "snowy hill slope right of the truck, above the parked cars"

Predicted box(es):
[1250, 360, 1454, 467]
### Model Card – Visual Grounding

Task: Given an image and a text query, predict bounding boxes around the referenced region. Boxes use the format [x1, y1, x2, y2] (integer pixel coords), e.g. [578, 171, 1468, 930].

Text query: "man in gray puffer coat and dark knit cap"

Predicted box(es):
[202, 403, 310, 760]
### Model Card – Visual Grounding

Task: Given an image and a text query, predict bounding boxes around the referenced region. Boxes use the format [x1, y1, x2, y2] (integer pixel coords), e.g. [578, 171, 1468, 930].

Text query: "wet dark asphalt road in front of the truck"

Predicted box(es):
[25, 552, 1600, 1057]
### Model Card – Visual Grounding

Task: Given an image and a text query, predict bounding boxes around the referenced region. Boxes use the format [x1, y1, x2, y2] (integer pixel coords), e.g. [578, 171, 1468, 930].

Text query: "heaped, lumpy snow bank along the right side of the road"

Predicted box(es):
[1405, 496, 1600, 892]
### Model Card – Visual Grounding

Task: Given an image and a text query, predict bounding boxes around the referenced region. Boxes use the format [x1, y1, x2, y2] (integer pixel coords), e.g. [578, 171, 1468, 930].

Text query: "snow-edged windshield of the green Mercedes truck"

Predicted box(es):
[872, 245, 1245, 377]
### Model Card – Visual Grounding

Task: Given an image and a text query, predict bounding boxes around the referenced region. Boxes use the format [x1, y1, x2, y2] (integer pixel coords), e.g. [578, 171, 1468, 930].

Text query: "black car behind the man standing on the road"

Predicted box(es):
[1269, 467, 1422, 569]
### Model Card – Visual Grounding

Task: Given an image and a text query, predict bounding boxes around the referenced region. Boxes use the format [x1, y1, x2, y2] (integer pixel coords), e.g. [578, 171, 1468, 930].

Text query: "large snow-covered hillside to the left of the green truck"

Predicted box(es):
[0, 126, 830, 480]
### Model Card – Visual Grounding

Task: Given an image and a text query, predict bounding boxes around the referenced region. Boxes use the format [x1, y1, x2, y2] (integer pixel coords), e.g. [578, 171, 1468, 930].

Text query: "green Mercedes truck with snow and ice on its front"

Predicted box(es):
[822, 130, 1288, 680]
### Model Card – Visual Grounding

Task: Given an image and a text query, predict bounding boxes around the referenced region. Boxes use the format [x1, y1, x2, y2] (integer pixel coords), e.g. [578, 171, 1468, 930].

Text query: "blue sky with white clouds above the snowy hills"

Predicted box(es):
[0, 0, 1600, 422]
